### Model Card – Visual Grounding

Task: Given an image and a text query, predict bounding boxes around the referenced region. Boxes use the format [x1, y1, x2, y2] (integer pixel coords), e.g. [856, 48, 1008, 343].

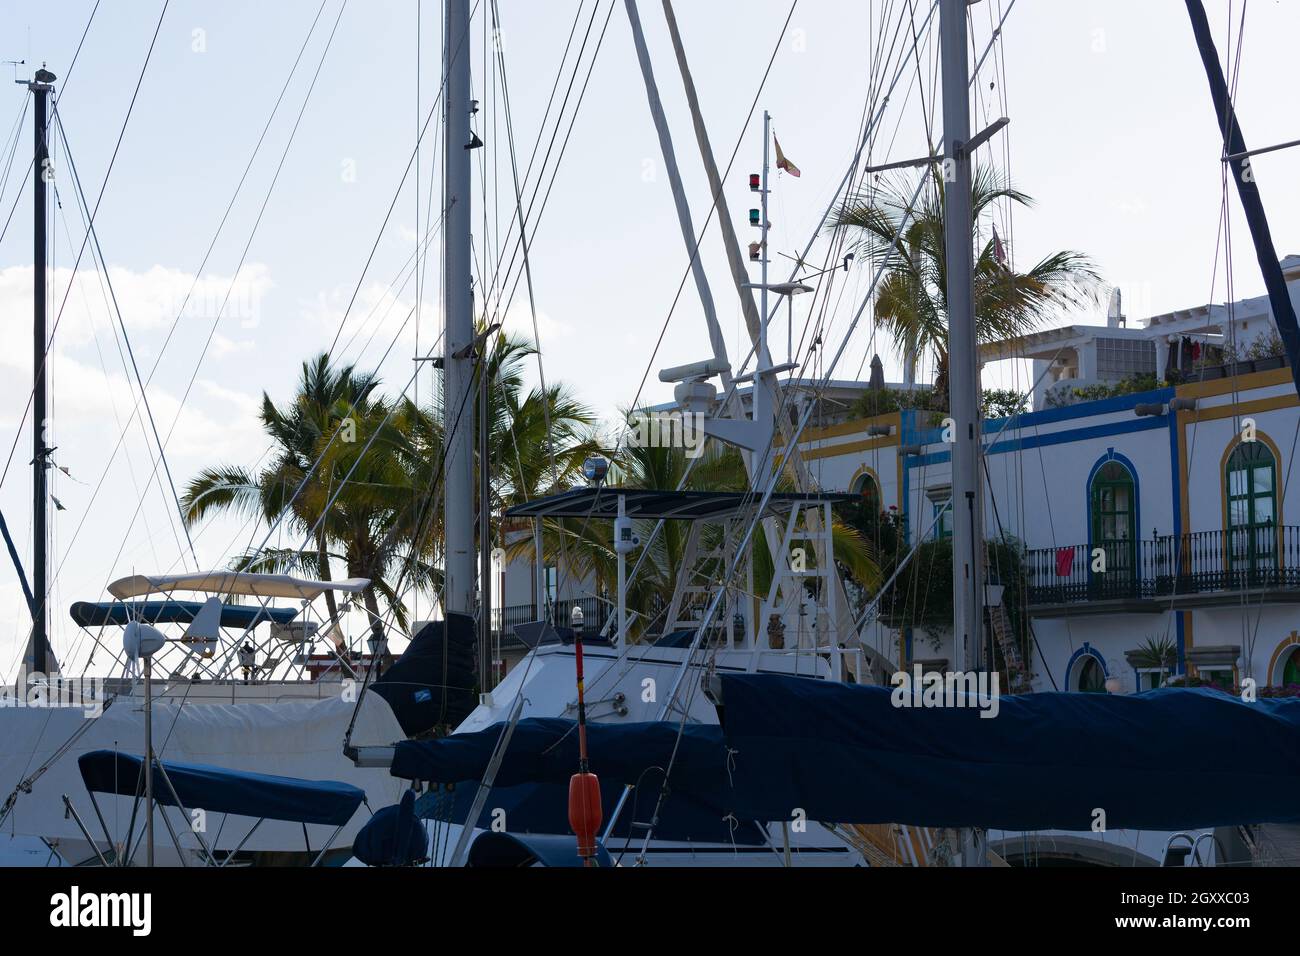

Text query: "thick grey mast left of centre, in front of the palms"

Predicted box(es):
[442, 0, 475, 614]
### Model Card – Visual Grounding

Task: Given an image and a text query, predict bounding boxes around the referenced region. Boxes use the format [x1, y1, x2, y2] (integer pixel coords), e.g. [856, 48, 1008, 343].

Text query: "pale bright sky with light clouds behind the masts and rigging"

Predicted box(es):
[0, 0, 1300, 674]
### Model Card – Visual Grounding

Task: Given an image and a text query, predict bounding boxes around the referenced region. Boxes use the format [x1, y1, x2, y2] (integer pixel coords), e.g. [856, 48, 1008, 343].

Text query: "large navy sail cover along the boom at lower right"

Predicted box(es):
[717, 674, 1300, 830]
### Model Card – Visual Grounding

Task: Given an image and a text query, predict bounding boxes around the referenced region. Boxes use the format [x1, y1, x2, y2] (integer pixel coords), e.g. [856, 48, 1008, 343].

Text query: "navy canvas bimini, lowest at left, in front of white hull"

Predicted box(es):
[77, 750, 365, 826]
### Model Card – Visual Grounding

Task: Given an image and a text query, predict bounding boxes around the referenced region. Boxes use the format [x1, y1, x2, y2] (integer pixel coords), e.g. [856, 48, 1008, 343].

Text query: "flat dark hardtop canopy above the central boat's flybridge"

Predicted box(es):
[506, 486, 862, 522]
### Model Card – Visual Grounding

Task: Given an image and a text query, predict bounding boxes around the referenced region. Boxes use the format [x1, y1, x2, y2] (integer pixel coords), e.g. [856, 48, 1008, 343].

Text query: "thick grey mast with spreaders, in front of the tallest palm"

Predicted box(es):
[939, 0, 984, 670]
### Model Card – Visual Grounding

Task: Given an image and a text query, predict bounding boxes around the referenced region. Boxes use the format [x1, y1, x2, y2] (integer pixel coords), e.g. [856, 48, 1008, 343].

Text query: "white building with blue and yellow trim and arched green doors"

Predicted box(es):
[802, 256, 1300, 692]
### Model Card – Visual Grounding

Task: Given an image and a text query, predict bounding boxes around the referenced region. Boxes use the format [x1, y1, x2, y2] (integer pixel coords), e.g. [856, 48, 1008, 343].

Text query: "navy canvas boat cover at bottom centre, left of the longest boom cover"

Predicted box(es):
[393, 717, 764, 845]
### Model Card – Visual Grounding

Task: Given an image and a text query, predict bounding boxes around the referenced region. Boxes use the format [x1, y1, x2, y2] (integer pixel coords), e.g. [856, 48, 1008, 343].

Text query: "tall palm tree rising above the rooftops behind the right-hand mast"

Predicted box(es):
[831, 166, 1100, 407]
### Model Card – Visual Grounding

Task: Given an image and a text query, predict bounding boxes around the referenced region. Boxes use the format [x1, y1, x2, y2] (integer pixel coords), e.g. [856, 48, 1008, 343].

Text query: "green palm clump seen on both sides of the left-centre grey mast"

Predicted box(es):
[182, 336, 599, 645]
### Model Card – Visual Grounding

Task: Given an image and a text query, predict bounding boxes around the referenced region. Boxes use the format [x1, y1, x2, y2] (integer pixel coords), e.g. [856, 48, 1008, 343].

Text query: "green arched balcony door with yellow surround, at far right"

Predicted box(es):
[1223, 441, 1278, 572]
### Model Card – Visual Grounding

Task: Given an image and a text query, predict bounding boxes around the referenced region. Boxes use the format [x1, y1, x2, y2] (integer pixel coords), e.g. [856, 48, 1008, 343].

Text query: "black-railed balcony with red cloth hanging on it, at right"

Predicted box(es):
[1026, 524, 1300, 617]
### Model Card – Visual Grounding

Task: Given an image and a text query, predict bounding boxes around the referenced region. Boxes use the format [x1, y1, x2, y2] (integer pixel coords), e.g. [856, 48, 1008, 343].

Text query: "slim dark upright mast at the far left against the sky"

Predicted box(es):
[26, 68, 55, 674]
